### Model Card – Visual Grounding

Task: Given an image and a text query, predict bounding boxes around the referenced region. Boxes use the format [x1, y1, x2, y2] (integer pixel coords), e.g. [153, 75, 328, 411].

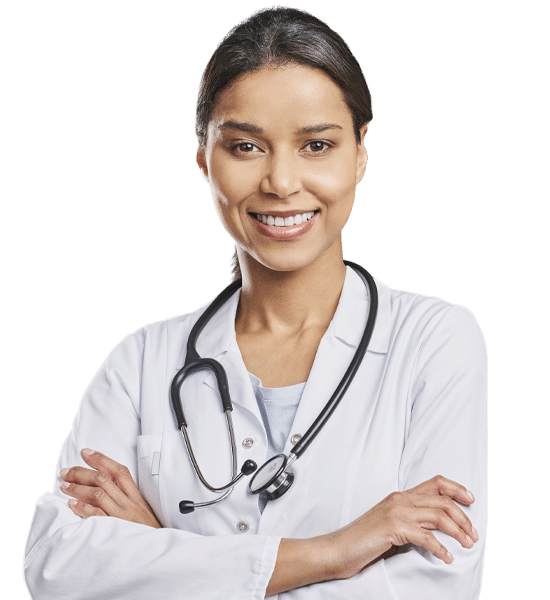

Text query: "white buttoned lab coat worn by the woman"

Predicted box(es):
[24, 267, 487, 600]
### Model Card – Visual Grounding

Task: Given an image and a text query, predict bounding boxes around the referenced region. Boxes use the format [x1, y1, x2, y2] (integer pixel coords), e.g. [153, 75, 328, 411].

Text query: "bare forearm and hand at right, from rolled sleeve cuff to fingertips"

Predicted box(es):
[267, 476, 479, 597]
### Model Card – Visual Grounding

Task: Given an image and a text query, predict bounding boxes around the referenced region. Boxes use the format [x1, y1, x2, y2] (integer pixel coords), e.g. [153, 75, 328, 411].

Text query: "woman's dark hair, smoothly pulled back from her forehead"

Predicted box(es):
[195, 4, 372, 280]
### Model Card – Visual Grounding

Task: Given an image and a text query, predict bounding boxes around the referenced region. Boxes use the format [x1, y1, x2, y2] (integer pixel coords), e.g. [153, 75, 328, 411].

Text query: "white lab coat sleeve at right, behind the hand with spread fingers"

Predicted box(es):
[365, 306, 488, 600]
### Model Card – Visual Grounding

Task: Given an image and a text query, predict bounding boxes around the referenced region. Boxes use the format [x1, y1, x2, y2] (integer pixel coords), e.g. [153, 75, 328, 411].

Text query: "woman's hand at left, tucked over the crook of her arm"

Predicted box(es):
[60, 448, 161, 529]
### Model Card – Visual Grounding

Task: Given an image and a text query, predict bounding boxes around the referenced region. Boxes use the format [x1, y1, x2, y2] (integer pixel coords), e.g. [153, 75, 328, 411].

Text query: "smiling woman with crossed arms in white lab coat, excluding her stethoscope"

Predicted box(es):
[25, 6, 487, 600]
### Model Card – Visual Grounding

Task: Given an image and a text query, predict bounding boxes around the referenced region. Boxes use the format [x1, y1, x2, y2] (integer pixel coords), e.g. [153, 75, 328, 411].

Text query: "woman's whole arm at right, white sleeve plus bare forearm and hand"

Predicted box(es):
[268, 307, 487, 600]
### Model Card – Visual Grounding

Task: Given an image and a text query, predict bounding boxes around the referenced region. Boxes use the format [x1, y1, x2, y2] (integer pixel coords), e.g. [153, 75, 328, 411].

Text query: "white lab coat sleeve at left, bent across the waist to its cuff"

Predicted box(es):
[23, 332, 280, 600]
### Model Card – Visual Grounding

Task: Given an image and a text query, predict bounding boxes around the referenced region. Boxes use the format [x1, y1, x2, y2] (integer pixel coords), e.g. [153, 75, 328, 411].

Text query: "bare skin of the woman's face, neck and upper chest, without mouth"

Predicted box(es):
[196, 66, 368, 387]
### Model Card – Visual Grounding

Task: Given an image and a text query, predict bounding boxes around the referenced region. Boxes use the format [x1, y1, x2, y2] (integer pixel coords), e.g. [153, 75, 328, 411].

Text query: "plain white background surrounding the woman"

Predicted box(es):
[0, 0, 548, 600]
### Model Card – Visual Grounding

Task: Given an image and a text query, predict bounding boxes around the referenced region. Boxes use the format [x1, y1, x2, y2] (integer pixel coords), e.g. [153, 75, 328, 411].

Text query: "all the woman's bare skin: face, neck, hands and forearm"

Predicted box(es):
[61, 66, 479, 596]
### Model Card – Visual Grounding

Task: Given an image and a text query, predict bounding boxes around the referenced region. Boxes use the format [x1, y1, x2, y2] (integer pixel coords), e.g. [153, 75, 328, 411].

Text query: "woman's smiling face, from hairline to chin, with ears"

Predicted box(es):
[197, 66, 367, 271]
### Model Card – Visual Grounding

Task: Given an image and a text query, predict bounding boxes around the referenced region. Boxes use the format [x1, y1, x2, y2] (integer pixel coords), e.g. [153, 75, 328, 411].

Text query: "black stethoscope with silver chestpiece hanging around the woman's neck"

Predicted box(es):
[170, 260, 378, 514]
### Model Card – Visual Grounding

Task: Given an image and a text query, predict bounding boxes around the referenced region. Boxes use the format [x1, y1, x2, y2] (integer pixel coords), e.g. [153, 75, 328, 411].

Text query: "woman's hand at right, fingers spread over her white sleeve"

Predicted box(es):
[323, 476, 479, 579]
